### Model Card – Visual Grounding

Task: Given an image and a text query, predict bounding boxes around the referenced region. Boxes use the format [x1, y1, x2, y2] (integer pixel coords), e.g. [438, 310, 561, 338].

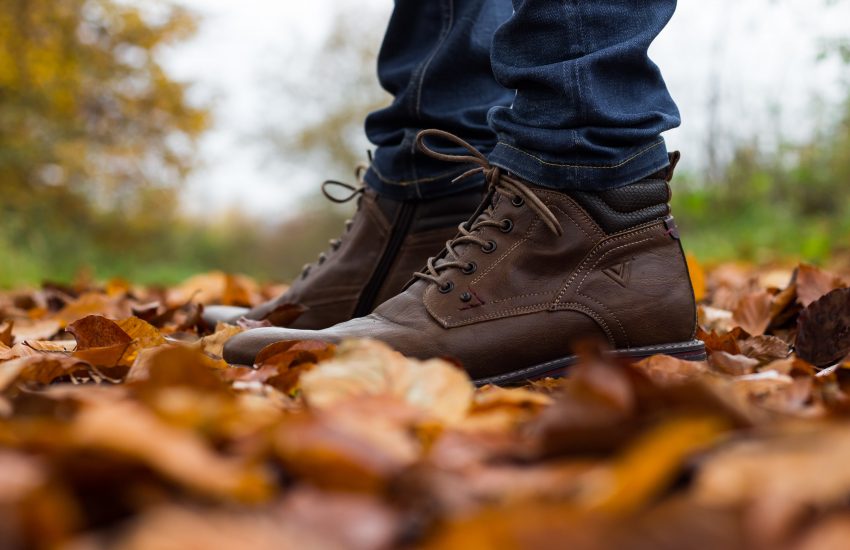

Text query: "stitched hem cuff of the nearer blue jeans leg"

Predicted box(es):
[489, 138, 670, 192]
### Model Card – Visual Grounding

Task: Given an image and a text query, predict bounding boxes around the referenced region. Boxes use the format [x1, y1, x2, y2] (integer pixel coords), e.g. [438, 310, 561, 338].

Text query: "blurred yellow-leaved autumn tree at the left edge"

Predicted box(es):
[0, 0, 208, 207]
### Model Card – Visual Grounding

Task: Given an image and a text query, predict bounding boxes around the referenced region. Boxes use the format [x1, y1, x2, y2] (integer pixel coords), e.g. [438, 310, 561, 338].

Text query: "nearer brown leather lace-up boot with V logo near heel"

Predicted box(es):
[224, 131, 705, 384]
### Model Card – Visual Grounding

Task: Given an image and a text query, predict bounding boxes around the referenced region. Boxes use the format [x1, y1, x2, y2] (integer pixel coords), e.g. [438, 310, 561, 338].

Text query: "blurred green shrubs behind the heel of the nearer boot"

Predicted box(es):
[674, 96, 850, 262]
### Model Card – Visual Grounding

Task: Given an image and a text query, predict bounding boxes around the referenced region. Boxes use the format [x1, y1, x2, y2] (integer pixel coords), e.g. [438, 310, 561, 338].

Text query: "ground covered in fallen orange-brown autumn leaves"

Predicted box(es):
[0, 262, 850, 550]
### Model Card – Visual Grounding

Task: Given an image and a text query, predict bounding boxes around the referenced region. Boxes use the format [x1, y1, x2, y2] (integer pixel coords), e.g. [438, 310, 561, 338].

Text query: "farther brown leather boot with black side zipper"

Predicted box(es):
[204, 172, 484, 330]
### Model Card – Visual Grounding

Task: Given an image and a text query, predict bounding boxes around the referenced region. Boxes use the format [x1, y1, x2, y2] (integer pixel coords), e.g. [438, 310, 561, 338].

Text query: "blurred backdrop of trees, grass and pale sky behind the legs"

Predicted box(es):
[0, 0, 850, 287]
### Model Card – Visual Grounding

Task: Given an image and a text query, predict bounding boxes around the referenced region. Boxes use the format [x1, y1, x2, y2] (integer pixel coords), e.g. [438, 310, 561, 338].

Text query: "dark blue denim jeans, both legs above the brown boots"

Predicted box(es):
[366, 0, 680, 199]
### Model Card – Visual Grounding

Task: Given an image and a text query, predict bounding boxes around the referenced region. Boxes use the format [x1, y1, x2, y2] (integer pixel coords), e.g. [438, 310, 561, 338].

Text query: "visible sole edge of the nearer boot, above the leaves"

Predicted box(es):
[474, 340, 708, 387]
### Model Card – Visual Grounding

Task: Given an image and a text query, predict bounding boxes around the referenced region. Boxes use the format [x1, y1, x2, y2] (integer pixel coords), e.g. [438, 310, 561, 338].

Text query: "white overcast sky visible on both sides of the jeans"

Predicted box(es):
[166, 0, 850, 218]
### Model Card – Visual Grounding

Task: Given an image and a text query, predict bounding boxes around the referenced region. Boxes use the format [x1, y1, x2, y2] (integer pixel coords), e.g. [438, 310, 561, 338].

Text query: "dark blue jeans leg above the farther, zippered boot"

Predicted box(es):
[366, 0, 514, 199]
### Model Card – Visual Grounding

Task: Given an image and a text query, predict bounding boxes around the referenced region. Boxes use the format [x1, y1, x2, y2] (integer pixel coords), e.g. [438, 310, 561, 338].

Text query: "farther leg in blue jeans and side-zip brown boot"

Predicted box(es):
[204, 0, 513, 329]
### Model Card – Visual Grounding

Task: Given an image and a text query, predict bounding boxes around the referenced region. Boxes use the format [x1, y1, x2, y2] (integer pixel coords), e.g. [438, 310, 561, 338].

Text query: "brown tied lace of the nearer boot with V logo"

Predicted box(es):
[413, 130, 564, 293]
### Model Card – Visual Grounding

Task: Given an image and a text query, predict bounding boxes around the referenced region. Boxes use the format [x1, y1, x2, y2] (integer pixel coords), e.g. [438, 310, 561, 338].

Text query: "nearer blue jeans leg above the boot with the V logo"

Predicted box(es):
[490, 0, 679, 191]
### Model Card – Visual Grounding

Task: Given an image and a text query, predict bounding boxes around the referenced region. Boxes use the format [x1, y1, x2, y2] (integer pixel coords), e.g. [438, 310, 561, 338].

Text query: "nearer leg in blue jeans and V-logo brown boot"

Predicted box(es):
[224, 0, 706, 384]
